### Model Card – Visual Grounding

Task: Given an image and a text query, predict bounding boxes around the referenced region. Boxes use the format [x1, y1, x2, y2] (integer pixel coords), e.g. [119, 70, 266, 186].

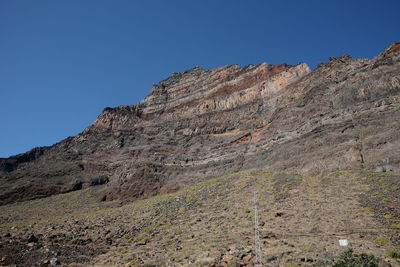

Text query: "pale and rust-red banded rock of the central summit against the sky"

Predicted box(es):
[140, 63, 311, 115]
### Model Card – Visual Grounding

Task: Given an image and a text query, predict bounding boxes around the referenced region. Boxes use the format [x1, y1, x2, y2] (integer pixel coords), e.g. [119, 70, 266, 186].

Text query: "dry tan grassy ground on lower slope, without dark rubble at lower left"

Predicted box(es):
[0, 170, 399, 266]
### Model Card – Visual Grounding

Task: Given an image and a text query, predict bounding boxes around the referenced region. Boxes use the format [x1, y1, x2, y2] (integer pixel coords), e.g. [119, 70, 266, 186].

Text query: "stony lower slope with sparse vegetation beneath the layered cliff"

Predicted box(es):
[0, 170, 400, 267]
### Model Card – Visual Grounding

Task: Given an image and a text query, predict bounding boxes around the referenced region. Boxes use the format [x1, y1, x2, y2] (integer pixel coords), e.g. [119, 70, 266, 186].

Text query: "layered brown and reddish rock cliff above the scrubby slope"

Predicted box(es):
[0, 43, 400, 204]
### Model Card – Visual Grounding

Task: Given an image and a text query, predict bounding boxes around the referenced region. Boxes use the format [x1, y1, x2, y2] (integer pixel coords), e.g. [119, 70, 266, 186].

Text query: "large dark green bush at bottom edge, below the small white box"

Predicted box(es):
[313, 249, 379, 267]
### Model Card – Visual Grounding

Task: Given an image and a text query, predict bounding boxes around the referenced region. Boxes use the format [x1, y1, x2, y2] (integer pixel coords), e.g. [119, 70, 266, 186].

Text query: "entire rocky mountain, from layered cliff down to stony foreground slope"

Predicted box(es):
[0, 42, 400, 266]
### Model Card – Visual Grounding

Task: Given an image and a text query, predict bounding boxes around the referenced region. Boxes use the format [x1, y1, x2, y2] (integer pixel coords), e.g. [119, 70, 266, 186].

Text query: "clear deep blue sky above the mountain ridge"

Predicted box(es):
[0, 0, 400, 157]
